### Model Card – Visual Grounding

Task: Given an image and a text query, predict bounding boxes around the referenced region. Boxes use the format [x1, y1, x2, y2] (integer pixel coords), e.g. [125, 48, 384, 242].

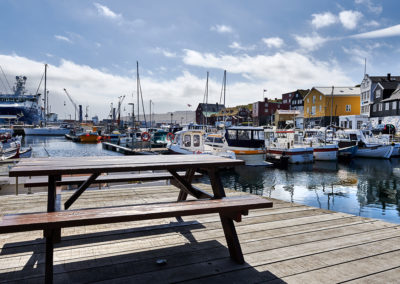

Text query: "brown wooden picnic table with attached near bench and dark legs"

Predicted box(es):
[0, 155, 272, 283]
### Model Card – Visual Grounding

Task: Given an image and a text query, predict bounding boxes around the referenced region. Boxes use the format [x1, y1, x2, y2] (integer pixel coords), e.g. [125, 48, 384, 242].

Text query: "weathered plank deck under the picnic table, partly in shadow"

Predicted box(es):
[0, 185, 400, 283]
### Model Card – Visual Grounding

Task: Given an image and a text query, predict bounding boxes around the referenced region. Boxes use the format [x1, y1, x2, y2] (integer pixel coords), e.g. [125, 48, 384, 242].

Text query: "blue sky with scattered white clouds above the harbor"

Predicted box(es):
[0, 0, 400, 119]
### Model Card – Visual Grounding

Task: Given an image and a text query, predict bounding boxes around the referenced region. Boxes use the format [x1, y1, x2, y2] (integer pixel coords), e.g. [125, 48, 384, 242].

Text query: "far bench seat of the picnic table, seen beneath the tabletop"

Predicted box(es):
[24, 172, 203, 187]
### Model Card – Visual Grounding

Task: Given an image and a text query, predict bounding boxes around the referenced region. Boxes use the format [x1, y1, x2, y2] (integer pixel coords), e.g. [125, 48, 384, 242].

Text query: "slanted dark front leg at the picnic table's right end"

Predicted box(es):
[208, 169, 244, 264]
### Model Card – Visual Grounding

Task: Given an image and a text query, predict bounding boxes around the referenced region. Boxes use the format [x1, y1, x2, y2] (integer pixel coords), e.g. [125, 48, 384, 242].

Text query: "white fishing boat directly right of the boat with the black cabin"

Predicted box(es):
[264, 129, 314, 164]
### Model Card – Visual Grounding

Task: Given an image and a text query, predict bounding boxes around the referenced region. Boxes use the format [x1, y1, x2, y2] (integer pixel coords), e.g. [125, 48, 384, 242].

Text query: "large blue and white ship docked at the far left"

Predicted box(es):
[0, 76, 41, 124]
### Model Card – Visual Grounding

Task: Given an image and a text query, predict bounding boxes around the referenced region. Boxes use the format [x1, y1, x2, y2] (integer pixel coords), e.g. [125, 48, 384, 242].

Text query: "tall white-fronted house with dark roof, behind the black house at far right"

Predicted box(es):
[360, 73, 400, 117]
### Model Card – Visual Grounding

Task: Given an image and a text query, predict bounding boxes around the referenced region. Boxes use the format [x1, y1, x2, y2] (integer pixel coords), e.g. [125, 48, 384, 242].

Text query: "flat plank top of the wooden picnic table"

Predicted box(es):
[9, 155, 244, 177]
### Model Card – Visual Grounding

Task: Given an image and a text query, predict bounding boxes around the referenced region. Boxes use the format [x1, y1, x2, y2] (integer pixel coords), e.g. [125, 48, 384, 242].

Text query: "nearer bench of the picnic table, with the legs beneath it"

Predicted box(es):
[0, 195, 272, 283]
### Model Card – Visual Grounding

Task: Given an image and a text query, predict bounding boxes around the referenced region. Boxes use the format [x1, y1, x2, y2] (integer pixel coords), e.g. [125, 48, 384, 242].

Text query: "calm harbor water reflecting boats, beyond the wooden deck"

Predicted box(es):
[23, 136, 400, 223]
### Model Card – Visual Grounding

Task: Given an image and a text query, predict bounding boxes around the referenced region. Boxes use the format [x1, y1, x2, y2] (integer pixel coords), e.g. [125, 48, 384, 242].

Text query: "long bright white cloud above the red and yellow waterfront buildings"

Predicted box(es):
[184, 50, 354, 91]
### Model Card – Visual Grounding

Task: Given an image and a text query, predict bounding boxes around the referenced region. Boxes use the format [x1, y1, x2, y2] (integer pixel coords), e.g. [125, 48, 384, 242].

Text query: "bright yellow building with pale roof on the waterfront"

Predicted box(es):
[304, 87, 360, 127]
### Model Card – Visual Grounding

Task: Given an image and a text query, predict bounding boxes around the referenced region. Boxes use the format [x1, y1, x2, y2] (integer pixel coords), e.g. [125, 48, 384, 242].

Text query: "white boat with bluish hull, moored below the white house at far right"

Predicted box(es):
[337, 129, 394, 159]
